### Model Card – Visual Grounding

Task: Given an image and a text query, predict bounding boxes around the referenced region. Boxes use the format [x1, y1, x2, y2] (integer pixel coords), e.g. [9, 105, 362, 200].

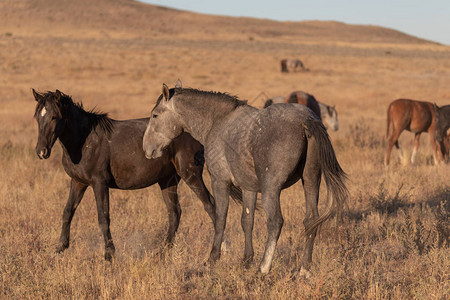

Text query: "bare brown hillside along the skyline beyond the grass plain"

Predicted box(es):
[0, 0, 436, 44]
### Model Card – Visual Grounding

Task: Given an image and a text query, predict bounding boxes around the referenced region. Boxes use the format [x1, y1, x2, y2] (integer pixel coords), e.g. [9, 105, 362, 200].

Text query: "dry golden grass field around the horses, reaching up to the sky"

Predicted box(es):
[0, 0, 450, 299]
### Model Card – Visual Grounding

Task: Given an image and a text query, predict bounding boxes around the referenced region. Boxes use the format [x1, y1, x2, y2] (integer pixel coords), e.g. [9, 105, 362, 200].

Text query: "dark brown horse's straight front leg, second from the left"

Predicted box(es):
[92, 182, 115, 261]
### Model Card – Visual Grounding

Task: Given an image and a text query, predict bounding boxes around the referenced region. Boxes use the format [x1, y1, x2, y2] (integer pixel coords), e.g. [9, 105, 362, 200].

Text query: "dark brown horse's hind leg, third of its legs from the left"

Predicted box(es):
[158, 176, 181, 247]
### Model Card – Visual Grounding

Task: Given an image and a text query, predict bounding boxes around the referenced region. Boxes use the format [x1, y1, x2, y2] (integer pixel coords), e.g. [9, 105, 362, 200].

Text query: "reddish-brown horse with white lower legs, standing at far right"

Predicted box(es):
[384, 99, 443, 166]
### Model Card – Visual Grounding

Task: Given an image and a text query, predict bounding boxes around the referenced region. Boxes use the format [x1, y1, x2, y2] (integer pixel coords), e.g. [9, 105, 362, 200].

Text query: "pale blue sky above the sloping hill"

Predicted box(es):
[140, 0, 450, 45]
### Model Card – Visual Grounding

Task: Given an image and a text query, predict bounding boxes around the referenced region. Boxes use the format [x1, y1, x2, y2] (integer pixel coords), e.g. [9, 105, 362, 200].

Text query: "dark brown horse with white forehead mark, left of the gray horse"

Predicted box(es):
[33, 90, 215, 260]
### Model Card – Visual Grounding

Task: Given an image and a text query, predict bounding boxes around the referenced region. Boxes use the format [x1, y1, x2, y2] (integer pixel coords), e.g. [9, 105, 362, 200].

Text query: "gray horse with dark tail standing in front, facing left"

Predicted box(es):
[143, 81, 348, 276]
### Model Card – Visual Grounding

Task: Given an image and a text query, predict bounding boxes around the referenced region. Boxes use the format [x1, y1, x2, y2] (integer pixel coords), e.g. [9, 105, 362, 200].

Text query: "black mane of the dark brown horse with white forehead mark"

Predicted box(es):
[34, 91, 114, 135]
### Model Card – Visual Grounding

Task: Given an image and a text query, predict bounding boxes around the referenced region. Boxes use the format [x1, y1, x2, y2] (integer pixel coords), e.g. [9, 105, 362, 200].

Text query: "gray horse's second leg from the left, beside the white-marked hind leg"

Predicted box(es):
[241, 190, 257, 268]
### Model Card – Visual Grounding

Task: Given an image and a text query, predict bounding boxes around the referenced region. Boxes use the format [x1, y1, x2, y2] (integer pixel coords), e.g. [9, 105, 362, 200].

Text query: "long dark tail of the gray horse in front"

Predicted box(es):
[304, 117, 349, 235]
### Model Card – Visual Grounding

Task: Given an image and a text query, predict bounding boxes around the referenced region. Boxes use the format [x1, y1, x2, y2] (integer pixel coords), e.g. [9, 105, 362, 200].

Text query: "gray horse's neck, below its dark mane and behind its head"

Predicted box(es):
[175, 97, 239, 145]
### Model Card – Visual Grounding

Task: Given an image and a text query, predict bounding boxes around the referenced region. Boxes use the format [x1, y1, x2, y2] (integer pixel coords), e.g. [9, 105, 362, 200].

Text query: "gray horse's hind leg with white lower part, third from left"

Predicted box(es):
[259, 189, 284, 274]
